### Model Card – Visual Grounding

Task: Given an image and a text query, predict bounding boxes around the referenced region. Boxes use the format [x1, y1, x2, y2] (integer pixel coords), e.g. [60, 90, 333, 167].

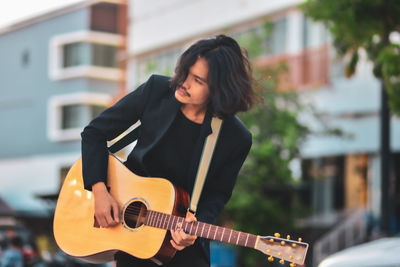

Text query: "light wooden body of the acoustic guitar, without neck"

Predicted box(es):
[54, 155, 189, 264]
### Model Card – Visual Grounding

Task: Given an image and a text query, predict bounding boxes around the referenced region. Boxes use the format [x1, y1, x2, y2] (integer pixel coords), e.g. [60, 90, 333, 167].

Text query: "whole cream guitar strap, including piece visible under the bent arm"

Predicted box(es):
[108, 117, 222, 218]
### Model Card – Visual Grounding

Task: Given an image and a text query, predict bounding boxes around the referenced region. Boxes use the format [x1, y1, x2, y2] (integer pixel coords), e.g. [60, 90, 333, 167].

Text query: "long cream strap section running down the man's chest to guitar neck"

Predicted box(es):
[186, 117, 222, 216]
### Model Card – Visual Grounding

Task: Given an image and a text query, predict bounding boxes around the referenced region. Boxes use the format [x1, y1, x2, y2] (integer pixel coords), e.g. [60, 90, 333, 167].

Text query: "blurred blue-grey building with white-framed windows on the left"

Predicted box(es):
[0, 0, 127, 260]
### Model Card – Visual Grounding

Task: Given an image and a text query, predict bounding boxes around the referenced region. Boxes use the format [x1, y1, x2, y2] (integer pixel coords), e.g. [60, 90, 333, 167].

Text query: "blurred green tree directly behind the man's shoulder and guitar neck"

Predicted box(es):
[223, 28, 308, 266]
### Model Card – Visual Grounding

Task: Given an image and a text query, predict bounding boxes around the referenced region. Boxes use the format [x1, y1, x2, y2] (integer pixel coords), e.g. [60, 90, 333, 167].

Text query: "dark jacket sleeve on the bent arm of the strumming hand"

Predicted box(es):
[81, 76, 154, 190]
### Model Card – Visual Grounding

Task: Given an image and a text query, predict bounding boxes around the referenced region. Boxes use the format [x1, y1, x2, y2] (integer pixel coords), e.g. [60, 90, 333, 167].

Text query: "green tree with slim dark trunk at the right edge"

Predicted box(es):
[302, 0, 400, 237]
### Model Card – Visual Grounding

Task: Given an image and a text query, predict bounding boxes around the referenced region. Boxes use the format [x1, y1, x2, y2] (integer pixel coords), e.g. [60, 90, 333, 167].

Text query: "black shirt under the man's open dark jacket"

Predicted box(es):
[146, 110, 201, 192]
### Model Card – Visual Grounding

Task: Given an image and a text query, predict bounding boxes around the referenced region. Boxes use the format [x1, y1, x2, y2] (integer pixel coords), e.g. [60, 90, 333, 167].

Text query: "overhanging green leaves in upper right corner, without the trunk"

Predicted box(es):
[302, 0, 400, 116]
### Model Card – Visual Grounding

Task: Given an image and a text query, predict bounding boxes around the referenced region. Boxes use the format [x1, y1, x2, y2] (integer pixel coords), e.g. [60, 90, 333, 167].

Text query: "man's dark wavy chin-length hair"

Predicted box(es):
[171, 35, 259, 117]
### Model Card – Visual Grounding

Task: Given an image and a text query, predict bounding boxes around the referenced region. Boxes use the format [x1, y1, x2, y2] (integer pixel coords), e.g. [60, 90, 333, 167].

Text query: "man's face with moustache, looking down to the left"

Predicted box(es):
[175, 58, 210, 109]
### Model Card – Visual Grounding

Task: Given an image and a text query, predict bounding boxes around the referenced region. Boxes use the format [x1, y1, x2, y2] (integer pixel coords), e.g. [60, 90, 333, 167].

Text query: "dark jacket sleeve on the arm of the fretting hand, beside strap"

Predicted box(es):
[196, 136, 252, 226]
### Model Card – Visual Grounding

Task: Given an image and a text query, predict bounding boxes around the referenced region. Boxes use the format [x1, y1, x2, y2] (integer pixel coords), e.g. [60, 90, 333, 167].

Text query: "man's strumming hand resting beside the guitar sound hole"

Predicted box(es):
[92, 182, 119, 227]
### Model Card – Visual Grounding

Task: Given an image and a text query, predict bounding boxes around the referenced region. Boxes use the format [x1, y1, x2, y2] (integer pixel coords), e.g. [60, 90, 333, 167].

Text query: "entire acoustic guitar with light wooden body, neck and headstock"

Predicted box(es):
[53, 155, 308, 266]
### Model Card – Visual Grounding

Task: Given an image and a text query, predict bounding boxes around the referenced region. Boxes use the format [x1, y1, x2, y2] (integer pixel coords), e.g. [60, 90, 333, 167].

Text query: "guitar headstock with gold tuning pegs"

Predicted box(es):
[255, 234, 308, 267]
